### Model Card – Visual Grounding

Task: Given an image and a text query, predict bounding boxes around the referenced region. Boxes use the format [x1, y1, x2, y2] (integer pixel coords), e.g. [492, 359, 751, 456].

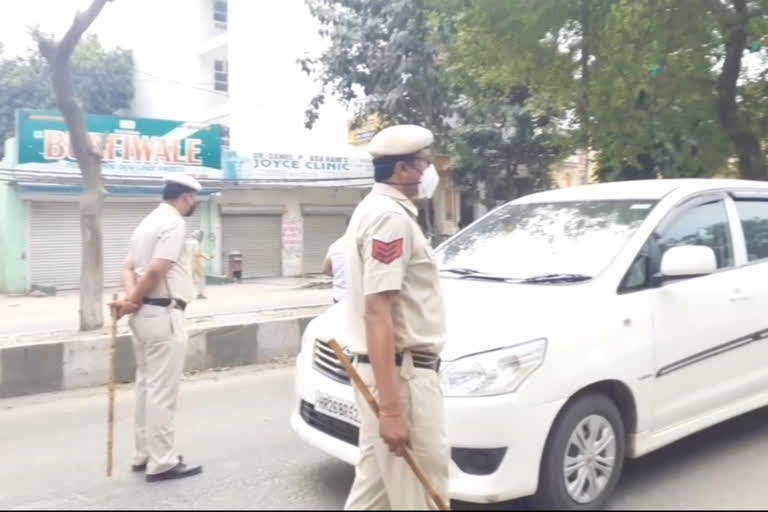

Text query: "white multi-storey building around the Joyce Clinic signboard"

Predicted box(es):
[89, 0, 372, 278]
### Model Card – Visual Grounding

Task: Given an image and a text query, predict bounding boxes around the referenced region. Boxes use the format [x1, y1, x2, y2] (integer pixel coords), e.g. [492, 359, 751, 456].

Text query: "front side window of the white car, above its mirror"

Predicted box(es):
[656, 200, 734, 269]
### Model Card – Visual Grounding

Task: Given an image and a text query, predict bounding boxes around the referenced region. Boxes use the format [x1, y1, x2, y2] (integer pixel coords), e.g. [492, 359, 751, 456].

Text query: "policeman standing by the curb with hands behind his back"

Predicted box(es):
[111, 173, 202, 482]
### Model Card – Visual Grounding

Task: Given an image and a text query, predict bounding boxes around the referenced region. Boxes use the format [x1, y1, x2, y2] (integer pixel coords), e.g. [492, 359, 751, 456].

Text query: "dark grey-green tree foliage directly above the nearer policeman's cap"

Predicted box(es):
[300, 0, 557, 201]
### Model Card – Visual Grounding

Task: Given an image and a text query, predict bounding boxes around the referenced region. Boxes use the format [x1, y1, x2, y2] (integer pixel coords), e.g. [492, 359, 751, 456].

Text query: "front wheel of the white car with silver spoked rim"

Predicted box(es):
[532, 394, 626, 510]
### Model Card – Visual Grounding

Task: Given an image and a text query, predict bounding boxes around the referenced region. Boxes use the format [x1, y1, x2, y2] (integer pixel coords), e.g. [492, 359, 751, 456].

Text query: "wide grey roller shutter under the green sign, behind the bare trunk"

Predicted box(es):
[29, 201, 200, 290]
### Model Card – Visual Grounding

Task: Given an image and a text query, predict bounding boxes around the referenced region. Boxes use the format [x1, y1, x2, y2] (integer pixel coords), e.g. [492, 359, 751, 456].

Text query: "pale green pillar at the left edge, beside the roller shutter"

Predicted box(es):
[0, 183, 29, 293]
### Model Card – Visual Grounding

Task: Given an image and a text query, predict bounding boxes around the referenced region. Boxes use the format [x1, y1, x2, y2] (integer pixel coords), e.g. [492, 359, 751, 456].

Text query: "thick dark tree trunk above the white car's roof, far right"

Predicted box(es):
[717, 0, 768, 180]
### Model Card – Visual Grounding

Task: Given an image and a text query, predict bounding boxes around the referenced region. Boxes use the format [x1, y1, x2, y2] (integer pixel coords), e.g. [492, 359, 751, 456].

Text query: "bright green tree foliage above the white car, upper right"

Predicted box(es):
[448, 0, 768, 179]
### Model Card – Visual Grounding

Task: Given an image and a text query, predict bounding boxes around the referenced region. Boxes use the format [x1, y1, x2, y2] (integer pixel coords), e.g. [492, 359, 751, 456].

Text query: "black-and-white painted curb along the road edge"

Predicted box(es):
[0, 314, 317, 398]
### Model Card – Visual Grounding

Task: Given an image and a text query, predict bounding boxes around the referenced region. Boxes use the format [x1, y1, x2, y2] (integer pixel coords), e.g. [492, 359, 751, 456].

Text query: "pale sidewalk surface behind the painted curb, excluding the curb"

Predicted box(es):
[0, 276, 332, 347]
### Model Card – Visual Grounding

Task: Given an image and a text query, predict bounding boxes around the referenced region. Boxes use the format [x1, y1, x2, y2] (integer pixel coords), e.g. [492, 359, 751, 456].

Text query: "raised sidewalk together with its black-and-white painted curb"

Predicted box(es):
[0, 277, 332, 398]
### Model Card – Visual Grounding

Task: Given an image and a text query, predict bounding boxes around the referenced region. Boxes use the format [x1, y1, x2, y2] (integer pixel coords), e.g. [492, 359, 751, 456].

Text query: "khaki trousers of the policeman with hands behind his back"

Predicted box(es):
[129, 305, 187, 475]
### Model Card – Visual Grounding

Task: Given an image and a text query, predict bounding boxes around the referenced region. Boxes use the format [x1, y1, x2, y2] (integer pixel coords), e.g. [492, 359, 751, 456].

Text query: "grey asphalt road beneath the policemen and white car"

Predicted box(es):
[0, 368, 768, 510]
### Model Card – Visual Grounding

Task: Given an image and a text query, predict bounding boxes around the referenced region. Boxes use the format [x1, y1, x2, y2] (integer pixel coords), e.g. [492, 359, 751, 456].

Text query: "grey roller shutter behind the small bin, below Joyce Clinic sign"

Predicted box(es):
[221, 214, 283, 278]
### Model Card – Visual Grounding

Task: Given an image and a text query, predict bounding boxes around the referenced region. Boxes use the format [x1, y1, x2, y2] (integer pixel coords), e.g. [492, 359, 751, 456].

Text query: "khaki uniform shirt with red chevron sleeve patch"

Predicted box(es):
[344, 183, 445, 354]
